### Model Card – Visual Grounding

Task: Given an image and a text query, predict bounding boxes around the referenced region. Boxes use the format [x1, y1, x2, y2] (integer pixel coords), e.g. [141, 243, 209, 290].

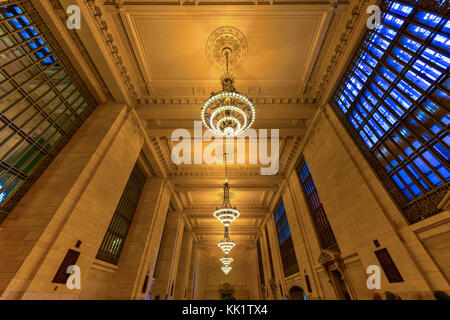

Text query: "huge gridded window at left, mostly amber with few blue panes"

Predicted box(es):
[0, 0, 97, 223]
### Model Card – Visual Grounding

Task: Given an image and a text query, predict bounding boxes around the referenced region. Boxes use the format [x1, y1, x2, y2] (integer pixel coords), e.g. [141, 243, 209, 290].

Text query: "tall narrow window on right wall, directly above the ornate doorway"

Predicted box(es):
[297, 159, 339, 251]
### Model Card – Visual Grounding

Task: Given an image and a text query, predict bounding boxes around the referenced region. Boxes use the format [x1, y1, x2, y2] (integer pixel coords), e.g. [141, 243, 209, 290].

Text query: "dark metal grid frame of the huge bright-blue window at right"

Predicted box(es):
[330, 0, 450, 223]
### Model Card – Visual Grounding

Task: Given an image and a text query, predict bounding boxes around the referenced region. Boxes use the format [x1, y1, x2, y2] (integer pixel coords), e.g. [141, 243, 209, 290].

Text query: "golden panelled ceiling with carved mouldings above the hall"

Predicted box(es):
[67, 0, 366, 243]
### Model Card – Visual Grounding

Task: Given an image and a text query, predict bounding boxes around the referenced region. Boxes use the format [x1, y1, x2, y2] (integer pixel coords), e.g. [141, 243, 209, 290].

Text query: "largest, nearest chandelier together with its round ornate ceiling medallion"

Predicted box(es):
[201, 27, 255, 137]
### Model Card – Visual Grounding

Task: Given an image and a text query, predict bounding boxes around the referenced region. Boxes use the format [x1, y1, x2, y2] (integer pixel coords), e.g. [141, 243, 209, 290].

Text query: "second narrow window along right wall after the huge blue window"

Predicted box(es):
[272, 199, 299, 277]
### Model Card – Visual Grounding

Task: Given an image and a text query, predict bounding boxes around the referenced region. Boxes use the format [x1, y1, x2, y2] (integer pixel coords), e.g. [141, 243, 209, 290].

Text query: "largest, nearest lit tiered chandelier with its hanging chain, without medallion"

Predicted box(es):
[202, 47, 255, 136]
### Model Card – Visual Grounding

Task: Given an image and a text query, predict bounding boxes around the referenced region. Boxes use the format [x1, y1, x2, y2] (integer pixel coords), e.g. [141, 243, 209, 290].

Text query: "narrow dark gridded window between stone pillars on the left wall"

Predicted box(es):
[97, 165, 146, 264]
